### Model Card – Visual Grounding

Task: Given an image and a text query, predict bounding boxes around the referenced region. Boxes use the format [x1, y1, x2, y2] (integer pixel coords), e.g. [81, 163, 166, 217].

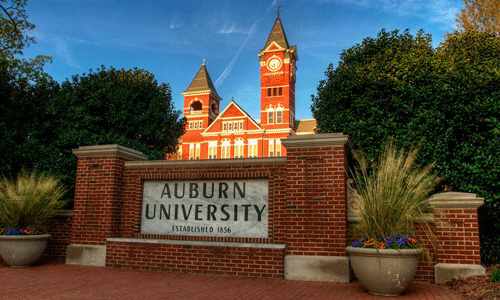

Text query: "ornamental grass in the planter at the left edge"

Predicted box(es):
[0, 172, 66, 235]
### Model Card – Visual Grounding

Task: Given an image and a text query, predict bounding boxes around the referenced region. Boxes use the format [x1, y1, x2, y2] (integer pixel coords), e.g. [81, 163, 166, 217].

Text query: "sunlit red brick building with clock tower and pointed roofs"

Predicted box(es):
[177, 14, 316, 159]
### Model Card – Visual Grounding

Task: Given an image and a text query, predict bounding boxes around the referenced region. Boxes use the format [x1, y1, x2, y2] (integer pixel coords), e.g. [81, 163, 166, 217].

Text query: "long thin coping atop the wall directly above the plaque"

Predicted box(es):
[125, 157, 286, 168]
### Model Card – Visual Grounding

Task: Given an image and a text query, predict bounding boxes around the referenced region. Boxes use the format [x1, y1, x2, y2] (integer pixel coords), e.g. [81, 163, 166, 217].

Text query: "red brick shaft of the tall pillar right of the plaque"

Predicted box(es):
[283, 146, 347, 256]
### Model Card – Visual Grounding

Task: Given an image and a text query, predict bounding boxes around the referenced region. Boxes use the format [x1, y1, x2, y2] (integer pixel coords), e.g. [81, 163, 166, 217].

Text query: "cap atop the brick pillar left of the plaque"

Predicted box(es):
[72, 144, 148, 160]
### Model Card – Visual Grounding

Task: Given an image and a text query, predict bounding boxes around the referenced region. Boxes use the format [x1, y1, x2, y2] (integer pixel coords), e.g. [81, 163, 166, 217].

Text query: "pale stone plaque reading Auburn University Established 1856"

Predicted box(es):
[141, 179, 269, 238]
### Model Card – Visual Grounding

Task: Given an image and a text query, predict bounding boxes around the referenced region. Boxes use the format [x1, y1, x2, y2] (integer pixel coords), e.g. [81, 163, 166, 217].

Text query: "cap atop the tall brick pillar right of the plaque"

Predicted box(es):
[281, 132, 349, 149]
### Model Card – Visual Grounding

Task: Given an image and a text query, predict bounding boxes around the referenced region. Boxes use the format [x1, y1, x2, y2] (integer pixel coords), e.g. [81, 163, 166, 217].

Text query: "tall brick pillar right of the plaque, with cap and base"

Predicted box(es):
[282, 133, 350, 282]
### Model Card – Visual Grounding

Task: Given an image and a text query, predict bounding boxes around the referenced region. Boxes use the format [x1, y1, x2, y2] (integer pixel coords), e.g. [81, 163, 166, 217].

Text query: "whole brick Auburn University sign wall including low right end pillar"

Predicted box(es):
[66, 134, 482, 282]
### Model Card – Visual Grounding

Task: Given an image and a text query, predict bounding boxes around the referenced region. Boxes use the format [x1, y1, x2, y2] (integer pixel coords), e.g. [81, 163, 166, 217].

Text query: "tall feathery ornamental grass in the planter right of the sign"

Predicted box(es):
[351, 140, 441, 249]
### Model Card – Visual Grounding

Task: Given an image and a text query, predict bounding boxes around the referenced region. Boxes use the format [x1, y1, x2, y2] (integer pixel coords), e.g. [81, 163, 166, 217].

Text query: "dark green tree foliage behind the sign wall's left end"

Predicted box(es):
[0, 67, 185, 203]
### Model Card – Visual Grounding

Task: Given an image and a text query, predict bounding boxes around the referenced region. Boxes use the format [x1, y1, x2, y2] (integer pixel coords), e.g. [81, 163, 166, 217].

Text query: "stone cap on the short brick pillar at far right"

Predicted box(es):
[429, 192, 484, 209]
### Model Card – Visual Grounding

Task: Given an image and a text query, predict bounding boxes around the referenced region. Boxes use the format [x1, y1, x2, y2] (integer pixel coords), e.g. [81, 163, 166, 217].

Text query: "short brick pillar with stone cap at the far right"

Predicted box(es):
[429, 192, 485, 283]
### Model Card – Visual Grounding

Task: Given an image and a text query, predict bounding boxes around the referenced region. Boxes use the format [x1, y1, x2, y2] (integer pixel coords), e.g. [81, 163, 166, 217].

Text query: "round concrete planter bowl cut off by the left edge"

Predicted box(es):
[0, 234, 50, 267]
